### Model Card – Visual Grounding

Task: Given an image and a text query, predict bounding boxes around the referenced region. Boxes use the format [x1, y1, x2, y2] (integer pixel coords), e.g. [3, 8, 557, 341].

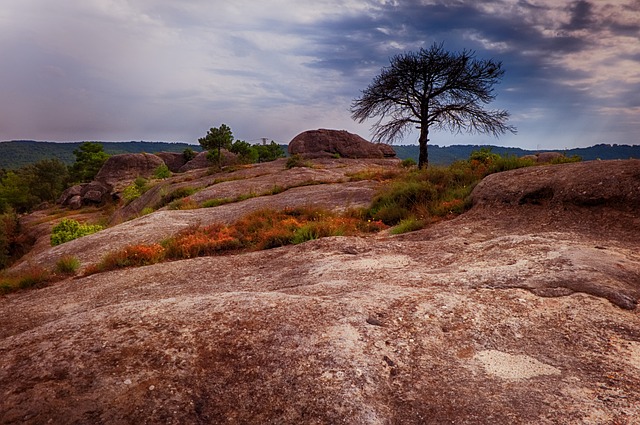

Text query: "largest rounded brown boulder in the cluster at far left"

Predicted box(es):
[95, 153, 165, 192]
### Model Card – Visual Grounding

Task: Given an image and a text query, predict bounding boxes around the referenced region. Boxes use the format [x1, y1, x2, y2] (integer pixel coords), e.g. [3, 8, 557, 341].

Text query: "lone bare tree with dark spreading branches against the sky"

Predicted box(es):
[351, 43, 516, 167]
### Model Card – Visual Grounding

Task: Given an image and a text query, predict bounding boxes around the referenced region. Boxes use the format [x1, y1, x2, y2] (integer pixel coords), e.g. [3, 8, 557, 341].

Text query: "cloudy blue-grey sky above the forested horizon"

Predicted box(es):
[0, 0, 640, 150]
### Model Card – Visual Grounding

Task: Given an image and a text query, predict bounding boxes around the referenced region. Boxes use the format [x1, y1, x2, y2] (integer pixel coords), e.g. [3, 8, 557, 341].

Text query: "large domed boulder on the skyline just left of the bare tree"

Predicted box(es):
[289, 129, 396, 158]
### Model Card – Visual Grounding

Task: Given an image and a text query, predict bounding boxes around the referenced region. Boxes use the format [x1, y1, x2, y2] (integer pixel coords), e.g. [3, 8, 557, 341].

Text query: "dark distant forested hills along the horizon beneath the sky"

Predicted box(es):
[0, 140, 640, 170]
